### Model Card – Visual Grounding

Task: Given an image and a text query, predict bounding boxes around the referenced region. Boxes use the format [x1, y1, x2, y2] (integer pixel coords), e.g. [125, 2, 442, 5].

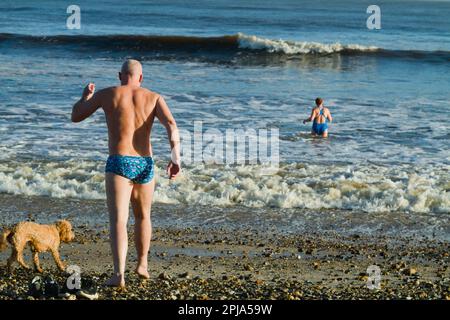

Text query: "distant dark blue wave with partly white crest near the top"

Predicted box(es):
[0, 33, 450, 63]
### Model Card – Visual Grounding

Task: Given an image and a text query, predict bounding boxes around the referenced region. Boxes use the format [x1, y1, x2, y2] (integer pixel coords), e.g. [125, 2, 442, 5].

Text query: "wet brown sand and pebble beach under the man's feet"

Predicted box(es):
[0, 222, 450, 300]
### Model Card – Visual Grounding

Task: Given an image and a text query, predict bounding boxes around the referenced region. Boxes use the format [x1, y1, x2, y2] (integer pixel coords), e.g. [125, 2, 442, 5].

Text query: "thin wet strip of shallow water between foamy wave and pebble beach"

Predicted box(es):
[0, 193, 450, 242]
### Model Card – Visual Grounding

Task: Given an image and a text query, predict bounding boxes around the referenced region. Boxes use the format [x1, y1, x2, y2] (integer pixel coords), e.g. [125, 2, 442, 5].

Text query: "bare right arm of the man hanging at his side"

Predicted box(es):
[156, 96, 181, 179]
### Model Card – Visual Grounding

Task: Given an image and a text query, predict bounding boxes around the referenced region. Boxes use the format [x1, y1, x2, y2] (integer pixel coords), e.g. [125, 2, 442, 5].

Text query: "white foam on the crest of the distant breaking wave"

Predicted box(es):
[238, 33, 379, 54]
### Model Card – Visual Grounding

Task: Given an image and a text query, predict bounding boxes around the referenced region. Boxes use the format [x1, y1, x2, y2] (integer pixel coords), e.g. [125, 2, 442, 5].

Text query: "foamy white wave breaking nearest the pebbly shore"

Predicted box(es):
[0, 160, 450, 213]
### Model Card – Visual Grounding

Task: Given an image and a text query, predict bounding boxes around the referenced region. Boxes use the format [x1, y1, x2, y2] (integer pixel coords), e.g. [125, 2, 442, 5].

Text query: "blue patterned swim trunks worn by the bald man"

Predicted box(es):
[105, 155, 154, 184]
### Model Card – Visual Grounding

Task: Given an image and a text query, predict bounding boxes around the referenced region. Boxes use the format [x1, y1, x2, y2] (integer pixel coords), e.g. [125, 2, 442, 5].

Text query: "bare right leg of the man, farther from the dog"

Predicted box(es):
[131, 178, 155, 279]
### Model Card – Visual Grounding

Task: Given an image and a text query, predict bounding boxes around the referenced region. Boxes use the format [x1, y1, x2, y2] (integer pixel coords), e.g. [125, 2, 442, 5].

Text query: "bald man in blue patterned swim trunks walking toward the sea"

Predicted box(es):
[72, 60, 180, 287]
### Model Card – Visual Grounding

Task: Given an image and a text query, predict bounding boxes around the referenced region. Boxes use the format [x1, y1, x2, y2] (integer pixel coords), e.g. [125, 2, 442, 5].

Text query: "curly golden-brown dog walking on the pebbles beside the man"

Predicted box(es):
[0, 220, 74, 272]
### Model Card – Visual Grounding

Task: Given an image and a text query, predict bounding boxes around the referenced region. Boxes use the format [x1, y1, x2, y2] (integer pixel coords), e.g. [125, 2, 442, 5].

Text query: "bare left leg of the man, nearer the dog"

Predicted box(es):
[105, 172, 133, 287]
